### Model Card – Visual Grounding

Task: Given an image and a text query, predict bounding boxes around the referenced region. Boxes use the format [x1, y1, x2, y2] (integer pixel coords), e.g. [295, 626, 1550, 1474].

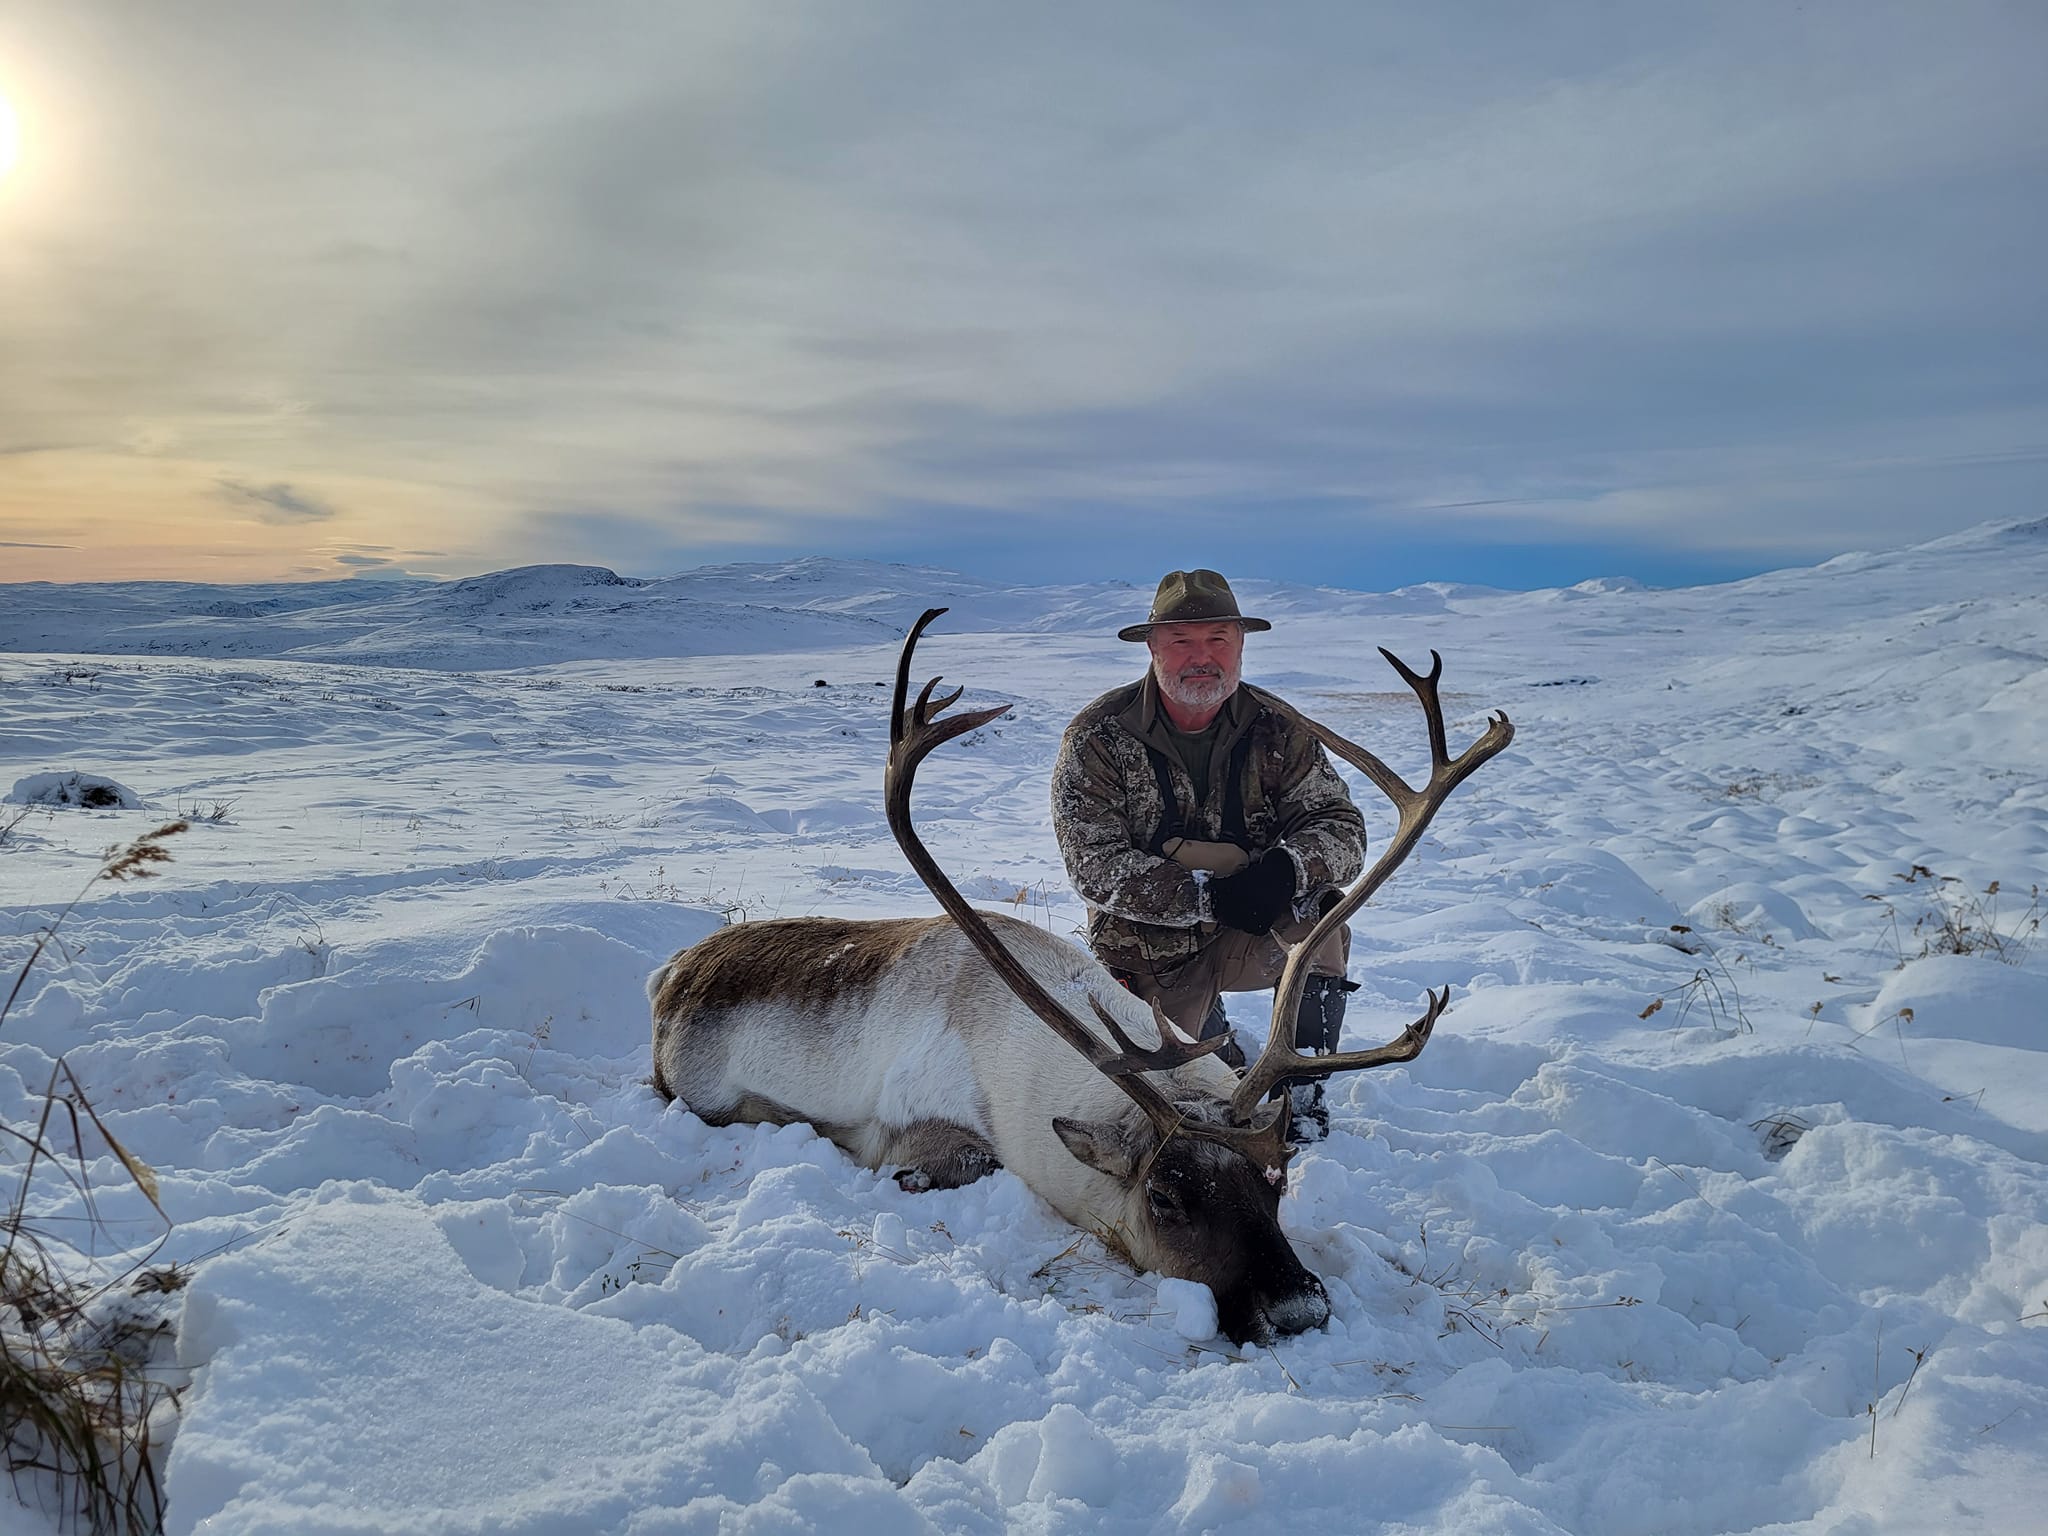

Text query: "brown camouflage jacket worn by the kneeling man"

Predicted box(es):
[1053, 672, 1366, 969]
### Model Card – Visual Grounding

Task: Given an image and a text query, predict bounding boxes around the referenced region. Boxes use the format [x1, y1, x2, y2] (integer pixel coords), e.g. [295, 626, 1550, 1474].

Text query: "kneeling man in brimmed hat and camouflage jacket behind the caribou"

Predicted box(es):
[1053, 569, 1366, 1141]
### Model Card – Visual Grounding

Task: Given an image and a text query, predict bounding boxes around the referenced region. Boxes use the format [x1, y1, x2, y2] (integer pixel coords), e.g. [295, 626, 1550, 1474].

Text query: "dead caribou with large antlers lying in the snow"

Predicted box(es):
[647, 608, 1513, 1346]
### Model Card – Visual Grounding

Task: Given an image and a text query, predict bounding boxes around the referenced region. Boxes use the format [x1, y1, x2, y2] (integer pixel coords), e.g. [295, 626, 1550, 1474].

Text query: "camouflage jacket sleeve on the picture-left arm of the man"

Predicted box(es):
[1053, 731, 1208, 928]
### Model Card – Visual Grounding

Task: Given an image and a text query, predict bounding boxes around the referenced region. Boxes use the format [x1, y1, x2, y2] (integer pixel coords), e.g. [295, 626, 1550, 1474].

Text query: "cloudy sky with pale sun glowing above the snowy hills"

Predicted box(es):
[0, 0, 2048, 590]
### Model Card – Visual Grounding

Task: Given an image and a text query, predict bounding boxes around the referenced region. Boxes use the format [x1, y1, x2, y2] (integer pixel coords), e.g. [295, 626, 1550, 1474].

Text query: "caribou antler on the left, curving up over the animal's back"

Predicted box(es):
[883, 608, 1229, 1163]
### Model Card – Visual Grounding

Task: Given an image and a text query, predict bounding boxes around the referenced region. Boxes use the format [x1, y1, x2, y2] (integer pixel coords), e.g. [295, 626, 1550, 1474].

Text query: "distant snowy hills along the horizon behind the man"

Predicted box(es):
[0, 518, 2048, 672]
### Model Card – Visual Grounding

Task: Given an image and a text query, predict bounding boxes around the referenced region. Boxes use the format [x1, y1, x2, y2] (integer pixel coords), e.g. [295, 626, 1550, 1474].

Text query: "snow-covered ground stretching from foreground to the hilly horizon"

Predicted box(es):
[0, 522, 2048, 1536]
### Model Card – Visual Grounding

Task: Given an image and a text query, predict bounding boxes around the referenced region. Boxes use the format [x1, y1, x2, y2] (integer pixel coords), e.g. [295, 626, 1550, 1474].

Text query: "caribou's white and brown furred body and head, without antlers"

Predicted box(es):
[647, 913, 1329, 1341]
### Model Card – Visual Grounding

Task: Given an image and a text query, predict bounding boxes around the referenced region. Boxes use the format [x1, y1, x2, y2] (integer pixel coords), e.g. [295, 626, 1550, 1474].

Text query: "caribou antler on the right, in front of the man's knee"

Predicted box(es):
[1231, 645, 1516, 1124]
